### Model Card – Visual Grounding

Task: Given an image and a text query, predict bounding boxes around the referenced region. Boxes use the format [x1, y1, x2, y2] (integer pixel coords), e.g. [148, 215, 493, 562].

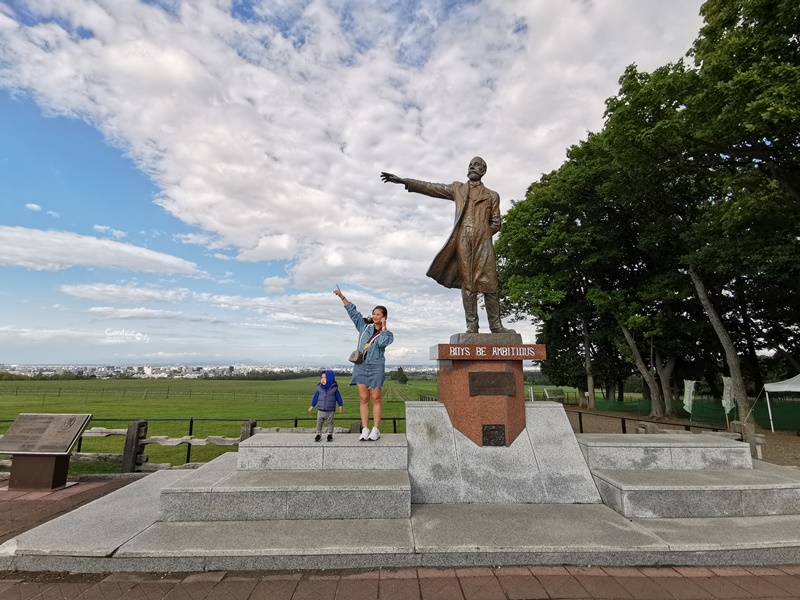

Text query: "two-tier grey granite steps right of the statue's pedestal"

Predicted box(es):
[576, 432, 800, 518]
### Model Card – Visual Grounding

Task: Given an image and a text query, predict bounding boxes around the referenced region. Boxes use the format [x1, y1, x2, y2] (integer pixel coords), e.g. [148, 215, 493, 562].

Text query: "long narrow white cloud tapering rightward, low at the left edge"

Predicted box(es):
[0, 226, 203, 277]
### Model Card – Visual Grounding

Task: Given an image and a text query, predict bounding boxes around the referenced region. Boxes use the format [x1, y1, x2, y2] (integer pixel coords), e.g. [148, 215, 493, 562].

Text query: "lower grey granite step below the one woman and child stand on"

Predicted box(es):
[158, 453, 411, 521]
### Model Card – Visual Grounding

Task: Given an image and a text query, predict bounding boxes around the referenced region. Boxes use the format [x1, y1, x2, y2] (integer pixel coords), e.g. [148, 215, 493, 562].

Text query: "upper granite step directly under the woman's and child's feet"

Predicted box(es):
[237, 433, 408, 471]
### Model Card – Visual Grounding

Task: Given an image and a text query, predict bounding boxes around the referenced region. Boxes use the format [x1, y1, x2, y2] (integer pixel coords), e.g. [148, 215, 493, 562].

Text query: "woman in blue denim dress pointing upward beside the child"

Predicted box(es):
[333, 286, 394, 442]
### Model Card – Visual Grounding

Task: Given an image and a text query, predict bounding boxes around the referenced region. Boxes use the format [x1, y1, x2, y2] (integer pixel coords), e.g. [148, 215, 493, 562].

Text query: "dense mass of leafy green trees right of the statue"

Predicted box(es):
[497, 0, 800, 416]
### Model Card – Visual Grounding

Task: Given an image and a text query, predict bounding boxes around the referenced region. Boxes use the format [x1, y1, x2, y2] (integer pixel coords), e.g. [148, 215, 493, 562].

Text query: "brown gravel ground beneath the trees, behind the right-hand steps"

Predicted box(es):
[565, 407, 800, 467]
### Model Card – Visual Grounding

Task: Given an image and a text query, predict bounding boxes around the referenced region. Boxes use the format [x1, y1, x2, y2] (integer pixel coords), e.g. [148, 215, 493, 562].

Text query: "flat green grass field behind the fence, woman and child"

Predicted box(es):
[0, 376, 436, 474]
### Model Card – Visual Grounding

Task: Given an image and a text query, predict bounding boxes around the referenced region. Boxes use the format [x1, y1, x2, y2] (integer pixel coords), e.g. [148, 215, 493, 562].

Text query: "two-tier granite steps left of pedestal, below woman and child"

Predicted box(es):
[158, 433, 411, 521]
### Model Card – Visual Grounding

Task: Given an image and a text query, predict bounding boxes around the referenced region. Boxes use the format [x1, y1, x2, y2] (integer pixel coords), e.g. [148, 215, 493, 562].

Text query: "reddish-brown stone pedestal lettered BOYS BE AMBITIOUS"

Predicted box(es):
[431, 334, 545, 447]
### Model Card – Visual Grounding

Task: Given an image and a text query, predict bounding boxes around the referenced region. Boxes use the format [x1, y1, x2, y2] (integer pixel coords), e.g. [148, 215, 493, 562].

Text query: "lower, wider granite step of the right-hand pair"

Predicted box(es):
[592, 467, 800, 518]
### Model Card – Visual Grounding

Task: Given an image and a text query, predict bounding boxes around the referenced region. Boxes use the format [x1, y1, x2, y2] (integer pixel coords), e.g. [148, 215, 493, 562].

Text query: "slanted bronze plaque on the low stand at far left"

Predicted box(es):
[0, 413, 92, 454]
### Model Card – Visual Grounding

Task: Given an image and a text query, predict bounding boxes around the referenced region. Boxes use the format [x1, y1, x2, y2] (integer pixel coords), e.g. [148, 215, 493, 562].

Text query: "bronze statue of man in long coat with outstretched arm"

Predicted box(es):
[381, 156, 515, 333]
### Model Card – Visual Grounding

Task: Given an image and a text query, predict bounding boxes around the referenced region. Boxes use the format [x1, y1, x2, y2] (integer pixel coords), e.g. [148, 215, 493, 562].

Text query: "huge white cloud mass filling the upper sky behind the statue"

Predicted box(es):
[0, 0, 700, 292]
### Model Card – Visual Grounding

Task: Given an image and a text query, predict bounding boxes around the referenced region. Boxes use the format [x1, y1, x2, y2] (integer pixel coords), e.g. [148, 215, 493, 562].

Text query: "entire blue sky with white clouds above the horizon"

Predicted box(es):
[0, 0, 701, 368]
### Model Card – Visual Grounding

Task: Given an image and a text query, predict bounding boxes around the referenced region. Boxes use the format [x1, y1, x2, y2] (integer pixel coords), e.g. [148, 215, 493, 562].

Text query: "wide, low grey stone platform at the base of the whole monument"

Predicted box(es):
[7, 471, 800, 573]
